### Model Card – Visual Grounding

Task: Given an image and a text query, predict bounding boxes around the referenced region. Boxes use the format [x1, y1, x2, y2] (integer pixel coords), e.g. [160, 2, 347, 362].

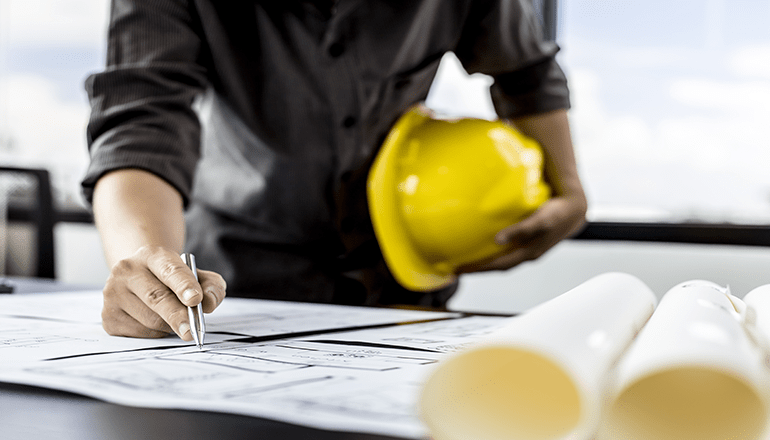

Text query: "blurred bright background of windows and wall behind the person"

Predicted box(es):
[0, 0, 770, 311]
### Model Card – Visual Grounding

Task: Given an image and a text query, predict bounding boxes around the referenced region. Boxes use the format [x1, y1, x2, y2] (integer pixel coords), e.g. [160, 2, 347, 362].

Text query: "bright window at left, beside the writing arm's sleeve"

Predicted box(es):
[0, 0, 109, 208]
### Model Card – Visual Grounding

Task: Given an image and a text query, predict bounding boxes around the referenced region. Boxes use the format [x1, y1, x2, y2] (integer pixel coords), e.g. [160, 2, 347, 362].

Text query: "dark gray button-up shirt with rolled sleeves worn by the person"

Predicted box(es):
[83, 0, 569, 302]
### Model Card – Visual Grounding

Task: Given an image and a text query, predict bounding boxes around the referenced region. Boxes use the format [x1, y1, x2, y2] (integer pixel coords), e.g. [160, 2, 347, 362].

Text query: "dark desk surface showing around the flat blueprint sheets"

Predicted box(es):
[0, 278, 408, 440]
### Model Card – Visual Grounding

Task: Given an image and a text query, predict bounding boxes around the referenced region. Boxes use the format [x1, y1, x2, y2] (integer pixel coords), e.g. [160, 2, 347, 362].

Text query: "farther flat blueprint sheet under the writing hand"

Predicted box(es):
[0, 291, 458, 368]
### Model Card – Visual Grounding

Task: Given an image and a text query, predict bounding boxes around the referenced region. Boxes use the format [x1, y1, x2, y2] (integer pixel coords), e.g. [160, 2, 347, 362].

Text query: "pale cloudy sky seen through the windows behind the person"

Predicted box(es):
[0, 0, 770, 223]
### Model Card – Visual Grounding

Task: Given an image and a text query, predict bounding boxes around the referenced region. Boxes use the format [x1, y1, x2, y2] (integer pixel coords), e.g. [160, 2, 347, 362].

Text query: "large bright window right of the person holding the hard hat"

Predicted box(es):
[431, 0, 770, 224]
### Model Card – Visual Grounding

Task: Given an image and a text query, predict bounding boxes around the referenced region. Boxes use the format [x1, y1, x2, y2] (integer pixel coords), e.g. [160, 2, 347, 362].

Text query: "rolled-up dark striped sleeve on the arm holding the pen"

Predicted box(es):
[82, 0, 207, 203]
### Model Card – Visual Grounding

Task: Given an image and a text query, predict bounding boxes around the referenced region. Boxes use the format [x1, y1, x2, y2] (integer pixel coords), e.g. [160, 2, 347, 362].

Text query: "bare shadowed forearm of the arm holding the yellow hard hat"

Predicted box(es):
[510, 110, 585, 203]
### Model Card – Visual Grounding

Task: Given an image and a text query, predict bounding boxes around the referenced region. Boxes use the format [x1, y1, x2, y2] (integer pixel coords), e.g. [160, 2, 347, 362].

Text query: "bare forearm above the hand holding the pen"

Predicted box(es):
[93, 169, 184, 267]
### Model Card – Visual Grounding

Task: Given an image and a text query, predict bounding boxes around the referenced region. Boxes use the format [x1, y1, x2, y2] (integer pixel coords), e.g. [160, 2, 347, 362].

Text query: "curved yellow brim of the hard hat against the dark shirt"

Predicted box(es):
[367, 108, 457, 291]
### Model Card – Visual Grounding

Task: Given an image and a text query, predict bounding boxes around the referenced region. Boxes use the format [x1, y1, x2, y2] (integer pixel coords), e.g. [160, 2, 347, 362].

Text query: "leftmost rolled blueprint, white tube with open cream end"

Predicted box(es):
[420, 273, 656, 440]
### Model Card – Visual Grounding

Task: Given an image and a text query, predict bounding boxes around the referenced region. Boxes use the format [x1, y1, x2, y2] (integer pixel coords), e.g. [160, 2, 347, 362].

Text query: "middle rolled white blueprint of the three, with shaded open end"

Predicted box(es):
[597, 280, 768, 440]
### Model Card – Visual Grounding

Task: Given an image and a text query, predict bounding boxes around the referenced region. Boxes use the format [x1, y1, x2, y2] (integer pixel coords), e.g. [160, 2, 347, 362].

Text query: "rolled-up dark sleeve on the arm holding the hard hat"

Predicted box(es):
[455, 0, 570, 118]
